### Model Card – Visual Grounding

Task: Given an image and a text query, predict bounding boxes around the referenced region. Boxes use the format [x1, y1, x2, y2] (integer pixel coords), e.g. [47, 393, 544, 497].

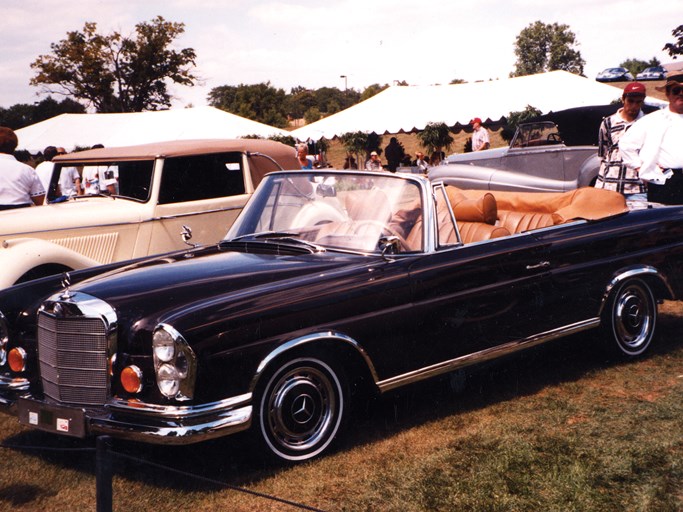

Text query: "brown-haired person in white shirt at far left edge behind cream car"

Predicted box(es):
[0, 126, 45, 210]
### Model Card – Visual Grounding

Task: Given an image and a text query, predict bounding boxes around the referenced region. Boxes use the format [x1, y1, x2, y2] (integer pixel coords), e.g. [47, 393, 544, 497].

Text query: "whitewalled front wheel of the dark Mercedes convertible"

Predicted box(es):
[257, 357, 348, 461]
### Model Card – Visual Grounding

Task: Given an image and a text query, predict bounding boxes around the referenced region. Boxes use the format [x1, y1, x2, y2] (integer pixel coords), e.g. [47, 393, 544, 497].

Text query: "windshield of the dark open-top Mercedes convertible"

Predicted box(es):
[226, 171, 422, 252]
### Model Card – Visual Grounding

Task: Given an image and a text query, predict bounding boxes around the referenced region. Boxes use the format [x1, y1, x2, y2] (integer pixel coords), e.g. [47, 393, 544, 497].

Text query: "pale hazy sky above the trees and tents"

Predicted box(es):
[0, 0, 683, 108]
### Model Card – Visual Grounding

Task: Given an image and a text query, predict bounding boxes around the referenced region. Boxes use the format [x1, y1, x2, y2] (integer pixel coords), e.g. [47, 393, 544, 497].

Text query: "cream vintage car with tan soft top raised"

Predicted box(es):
[0, 139, 299, 288]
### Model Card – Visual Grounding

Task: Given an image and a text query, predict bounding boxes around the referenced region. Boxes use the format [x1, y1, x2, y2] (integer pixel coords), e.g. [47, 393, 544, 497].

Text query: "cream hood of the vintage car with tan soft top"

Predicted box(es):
[0, 196, 144, 237]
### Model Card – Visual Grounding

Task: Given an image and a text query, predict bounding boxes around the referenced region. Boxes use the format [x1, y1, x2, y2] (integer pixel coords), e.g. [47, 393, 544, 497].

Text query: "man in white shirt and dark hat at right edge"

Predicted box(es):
[619, 73, 683, 204]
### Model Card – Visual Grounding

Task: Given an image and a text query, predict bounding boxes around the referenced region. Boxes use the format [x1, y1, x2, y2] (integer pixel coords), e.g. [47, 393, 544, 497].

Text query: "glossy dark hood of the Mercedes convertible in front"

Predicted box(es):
[71, 246, 368, 328]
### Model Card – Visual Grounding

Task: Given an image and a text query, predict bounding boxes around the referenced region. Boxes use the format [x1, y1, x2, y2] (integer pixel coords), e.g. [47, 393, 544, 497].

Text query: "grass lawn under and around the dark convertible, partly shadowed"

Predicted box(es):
[0, 303, 683, 511]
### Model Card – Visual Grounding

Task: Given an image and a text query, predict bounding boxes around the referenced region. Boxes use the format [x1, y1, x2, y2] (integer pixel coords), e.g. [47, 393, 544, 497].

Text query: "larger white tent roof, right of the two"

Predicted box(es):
[291, 71, 666, 140]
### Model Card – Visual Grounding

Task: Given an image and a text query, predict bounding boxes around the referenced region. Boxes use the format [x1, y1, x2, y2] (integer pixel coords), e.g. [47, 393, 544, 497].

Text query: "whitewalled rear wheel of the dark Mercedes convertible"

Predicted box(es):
[603, 279, 657, 357]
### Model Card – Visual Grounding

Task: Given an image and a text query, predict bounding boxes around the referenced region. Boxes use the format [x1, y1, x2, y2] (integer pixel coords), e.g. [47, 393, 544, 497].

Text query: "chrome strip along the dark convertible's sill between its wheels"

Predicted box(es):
[377, 318, 600, 393]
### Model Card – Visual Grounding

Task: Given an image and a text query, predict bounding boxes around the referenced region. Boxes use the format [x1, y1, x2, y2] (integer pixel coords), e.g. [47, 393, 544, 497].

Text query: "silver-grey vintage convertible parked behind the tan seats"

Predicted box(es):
[436, 121, 600, 192]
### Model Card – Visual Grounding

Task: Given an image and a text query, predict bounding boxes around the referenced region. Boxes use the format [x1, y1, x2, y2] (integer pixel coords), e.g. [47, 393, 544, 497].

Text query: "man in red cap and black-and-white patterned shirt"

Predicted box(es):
[595, 82, 647, 201]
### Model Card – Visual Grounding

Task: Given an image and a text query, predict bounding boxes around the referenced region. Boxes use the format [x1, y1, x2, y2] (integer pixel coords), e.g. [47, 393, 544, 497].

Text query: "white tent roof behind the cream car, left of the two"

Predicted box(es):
[16, 107, 289, 153]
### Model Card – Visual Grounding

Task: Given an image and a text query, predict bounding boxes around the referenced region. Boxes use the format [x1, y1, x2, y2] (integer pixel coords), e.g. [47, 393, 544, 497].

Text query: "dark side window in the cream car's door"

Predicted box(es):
[159, 152, 245, 204]
